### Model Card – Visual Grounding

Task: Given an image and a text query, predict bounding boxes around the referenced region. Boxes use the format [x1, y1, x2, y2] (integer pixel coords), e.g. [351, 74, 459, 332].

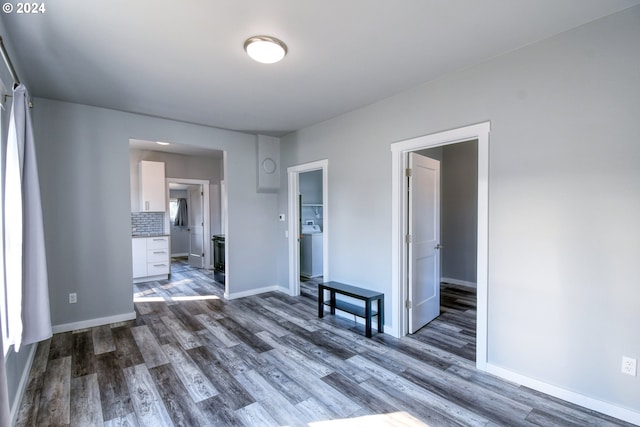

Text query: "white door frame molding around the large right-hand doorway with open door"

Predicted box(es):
[391, 121, 491, 370]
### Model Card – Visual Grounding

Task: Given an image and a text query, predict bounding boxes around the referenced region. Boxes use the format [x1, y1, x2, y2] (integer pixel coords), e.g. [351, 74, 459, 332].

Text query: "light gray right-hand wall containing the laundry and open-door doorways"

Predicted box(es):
[278, 7, 640, 411]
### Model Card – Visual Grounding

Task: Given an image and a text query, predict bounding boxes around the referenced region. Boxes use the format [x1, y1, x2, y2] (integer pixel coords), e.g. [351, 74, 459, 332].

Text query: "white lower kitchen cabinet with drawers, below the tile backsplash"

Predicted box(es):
[131, 236, 171, 283]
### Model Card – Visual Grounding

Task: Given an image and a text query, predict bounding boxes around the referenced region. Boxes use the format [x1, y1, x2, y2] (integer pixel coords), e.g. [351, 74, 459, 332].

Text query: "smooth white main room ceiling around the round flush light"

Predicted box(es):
[0, 0, 640, 136]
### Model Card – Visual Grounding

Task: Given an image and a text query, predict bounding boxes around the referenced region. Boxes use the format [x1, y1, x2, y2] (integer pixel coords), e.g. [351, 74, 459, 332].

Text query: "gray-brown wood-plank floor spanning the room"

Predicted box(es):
[17, 264, 628, 427]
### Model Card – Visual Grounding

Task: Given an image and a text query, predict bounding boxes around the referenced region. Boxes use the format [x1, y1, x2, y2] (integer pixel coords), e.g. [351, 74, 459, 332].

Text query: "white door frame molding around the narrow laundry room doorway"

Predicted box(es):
[287, 159, 329, 296]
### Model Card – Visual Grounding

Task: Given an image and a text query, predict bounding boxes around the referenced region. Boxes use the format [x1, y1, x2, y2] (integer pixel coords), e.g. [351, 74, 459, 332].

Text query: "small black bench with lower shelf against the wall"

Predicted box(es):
[318, 282, 384, 338]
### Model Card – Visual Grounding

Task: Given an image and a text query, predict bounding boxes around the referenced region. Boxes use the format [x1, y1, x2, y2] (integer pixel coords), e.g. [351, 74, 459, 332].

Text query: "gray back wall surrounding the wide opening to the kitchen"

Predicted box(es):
[34, 99, 277, 332]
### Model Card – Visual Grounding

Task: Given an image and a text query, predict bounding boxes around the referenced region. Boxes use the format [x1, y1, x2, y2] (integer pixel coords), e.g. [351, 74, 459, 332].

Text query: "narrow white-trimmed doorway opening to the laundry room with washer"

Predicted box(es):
[287, 160, 329, 296]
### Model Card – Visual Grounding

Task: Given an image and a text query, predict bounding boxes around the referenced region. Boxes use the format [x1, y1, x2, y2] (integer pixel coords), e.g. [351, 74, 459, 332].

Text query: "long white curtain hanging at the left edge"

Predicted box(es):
[3, 84, 51, 351]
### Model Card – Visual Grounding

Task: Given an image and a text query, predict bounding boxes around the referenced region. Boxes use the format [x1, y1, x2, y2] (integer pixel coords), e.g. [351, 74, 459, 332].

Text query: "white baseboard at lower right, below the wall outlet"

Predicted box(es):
[486, 363, 640, 425]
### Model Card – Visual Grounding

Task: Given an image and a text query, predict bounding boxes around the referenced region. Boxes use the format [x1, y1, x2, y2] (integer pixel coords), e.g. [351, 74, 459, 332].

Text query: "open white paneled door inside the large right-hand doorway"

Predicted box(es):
[407, 153, 440, 334]
